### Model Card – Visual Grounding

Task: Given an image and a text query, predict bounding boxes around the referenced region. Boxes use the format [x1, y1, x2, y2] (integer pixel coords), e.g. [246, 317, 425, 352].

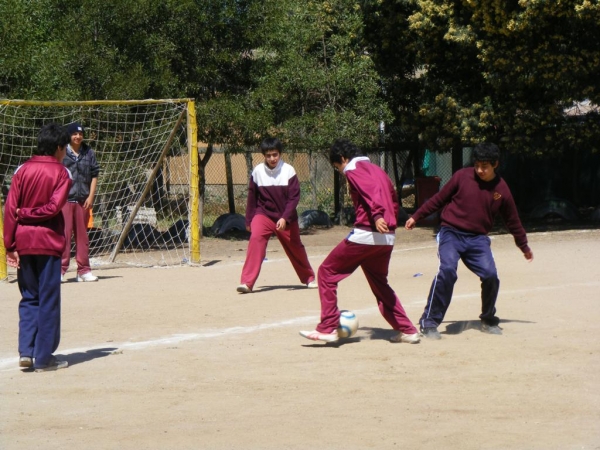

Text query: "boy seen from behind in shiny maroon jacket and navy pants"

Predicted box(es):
[4, 124, 71, 372]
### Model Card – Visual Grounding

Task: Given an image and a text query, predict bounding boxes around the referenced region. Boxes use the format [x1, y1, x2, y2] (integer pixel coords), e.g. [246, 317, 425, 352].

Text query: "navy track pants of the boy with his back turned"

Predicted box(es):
[17, 255, 60, 368]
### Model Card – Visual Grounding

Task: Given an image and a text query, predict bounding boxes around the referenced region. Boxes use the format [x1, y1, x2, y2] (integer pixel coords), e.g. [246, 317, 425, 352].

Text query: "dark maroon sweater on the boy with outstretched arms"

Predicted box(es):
[412, 167, 531, 253]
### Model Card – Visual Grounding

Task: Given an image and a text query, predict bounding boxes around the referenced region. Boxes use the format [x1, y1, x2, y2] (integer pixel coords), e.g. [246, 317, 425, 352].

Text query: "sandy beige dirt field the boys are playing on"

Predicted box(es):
[0, 228, 600, 450]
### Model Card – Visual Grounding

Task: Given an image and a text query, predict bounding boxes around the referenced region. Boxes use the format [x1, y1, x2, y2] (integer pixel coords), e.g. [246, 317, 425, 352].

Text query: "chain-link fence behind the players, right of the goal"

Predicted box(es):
[198, 142, 600, 232]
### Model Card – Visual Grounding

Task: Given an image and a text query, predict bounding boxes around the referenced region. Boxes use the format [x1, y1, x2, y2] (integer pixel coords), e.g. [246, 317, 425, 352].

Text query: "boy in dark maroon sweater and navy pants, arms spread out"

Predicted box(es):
[405, 143, 533, 339]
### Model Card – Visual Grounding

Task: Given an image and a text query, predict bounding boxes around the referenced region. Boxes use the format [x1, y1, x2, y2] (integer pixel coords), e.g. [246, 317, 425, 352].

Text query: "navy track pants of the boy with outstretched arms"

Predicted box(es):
[419, 227, 500, 328]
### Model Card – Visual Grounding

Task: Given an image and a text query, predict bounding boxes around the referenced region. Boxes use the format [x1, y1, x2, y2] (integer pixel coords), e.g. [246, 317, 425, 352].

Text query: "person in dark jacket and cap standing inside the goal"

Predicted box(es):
[61, 123, 100, 282]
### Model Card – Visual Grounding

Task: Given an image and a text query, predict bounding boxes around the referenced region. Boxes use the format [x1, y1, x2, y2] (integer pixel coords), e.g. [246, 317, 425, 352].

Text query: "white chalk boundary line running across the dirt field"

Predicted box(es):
[0, 281, 600, 372]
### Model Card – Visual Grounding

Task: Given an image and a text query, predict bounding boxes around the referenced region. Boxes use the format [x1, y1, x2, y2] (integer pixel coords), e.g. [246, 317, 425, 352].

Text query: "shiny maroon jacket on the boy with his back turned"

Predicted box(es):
[4, 156, 71, 256]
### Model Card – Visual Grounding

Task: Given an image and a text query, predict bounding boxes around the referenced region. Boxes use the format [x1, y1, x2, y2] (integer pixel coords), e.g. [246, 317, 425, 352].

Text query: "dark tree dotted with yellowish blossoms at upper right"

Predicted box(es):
[409, 0, 600, 153]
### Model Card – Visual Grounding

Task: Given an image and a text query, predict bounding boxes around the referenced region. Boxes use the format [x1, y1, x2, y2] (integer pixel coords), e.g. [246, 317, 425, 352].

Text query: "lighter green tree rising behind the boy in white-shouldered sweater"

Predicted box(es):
[250, 0, 391, 151]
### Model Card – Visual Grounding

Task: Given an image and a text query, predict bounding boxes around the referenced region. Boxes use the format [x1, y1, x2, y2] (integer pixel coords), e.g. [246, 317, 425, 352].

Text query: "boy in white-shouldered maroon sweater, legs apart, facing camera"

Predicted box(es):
[237, 138, 317, 294]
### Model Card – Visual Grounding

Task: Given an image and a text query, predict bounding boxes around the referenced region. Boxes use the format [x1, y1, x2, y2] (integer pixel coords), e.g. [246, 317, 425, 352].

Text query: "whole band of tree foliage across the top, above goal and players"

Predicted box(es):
[0, 0, 600, 157]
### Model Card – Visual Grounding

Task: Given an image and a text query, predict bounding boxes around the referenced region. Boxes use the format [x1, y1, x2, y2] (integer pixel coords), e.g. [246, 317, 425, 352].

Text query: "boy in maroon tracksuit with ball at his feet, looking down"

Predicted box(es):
[300, 139, 420, 344]
